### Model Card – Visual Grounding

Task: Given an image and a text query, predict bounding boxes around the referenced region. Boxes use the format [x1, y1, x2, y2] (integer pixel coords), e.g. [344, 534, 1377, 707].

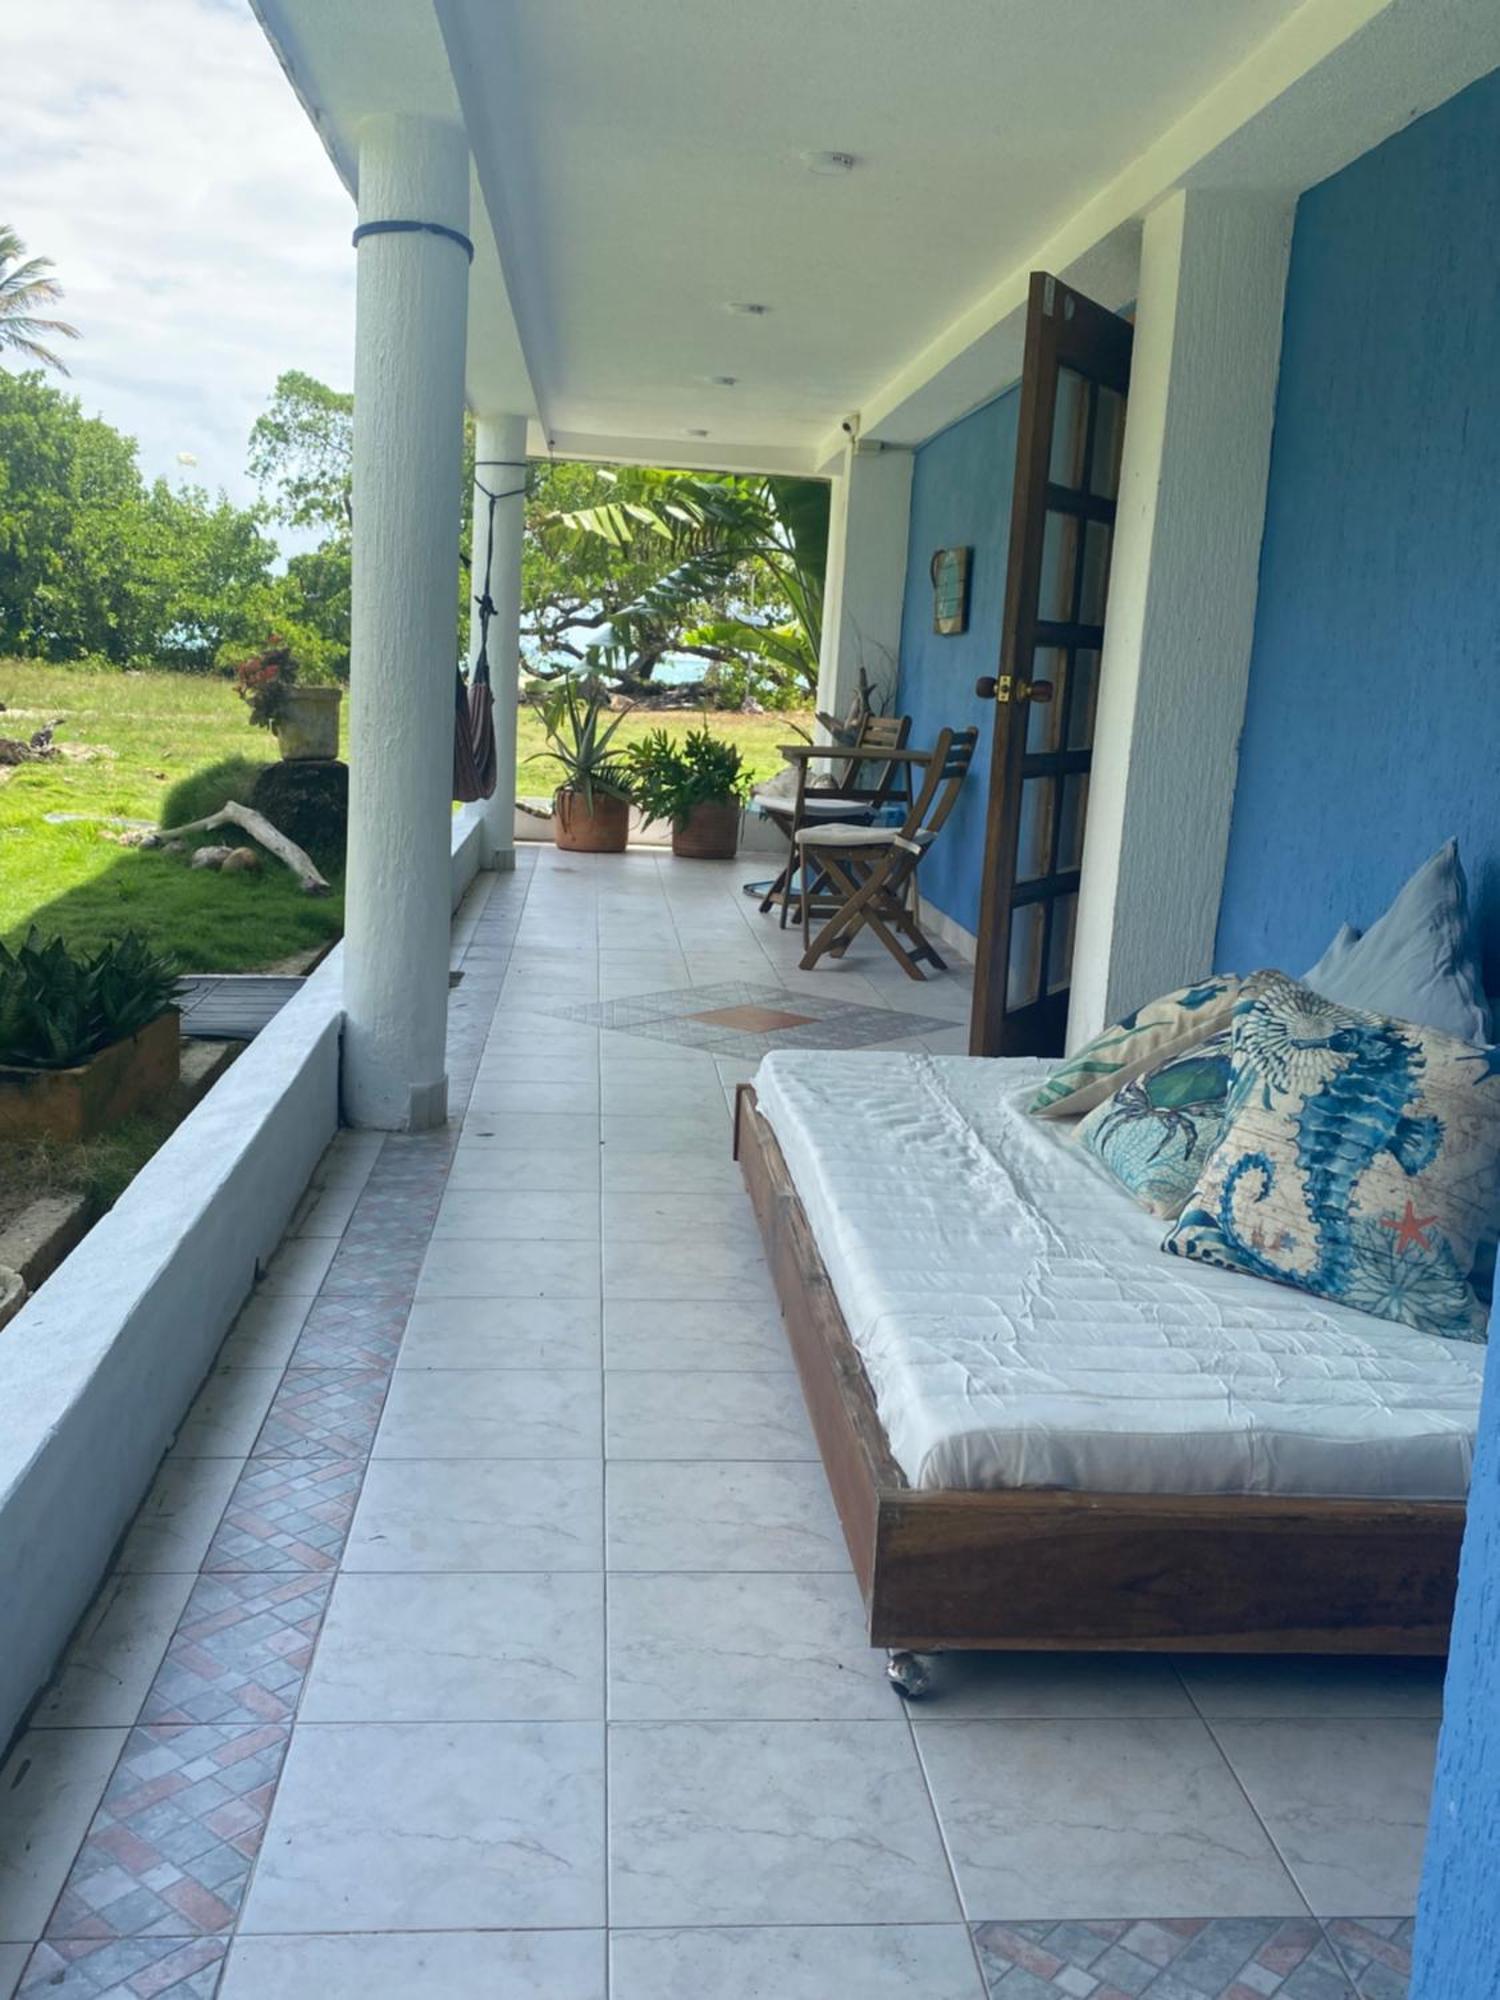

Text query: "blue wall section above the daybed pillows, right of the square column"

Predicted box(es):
[1218, 72, 1500, 992]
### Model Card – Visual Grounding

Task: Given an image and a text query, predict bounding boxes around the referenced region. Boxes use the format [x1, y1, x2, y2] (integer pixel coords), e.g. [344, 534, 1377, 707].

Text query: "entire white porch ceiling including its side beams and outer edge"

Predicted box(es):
[252, 0, 1500, 470]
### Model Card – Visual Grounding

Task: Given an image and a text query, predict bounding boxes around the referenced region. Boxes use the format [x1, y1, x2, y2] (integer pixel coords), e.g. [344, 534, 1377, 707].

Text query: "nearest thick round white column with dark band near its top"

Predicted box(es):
[344, 116, 468, 1130]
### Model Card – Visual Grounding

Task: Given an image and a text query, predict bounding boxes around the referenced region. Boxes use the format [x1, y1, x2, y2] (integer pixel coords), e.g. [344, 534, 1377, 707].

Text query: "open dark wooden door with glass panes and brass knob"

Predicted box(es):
[968, 272, 1132, 1056]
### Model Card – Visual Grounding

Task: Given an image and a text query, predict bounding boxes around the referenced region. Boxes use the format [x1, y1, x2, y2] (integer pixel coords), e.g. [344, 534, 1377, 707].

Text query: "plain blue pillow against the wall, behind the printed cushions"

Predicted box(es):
[1304, 840, 1490, 1042]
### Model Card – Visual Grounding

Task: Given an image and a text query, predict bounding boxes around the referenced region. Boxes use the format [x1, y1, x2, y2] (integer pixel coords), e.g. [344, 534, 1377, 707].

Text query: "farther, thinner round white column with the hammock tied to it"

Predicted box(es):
[468, 416, 526, 870]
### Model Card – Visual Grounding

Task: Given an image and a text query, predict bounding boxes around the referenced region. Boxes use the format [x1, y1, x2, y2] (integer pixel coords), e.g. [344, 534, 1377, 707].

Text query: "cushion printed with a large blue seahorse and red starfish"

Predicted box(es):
[1162, 972, 1500, 1340]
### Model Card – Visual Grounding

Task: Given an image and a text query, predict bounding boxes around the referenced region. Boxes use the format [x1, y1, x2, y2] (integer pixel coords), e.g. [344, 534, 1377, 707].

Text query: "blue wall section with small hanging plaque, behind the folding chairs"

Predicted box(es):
[898, 390, 1020, 932]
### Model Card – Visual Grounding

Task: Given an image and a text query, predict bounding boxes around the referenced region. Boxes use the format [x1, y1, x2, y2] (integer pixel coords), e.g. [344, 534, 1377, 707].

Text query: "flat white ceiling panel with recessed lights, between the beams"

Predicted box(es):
[438, 0, 1296, 446]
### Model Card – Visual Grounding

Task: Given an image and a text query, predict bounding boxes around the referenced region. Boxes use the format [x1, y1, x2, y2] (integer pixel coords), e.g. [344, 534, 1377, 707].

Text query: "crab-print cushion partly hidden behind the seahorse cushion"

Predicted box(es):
[1078, 1028, 1230, 1220]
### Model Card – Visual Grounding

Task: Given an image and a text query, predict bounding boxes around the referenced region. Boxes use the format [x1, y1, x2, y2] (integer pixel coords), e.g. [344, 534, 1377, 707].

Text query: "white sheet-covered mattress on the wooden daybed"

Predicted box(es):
[756, 1050, 1486, 1500]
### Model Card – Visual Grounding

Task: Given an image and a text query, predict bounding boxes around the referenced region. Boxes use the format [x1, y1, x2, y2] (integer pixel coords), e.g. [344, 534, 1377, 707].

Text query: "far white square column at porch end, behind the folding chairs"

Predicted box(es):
[818, 444, 912, 716]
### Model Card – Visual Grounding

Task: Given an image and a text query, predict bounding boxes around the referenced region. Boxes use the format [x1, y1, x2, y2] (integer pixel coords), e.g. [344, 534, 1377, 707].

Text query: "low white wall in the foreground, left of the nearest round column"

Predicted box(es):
[0, 948, 342, 1746]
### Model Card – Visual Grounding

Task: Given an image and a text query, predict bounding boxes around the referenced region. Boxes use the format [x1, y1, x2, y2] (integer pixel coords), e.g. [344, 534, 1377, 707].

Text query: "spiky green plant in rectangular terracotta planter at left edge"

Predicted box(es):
[0, 930, 180, 1140]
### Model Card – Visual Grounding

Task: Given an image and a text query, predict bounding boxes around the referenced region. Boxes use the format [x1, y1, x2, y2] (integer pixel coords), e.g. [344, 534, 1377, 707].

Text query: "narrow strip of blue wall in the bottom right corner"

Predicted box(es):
[1412, 1310, 1500, 2000]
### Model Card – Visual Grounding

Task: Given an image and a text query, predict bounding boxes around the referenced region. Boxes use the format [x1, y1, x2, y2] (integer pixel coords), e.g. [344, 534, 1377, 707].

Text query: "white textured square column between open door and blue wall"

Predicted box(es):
[1068, 190, 1292, 1048]
